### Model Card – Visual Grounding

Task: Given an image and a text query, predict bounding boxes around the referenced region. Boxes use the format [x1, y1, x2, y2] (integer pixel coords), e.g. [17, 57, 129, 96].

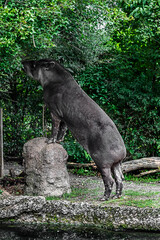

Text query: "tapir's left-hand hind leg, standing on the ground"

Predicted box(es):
[99, 167, 114, 201]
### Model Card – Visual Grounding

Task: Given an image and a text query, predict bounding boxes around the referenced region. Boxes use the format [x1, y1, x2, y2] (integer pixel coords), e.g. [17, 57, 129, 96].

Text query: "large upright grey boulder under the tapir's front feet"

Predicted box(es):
[23, 138, 71, 196]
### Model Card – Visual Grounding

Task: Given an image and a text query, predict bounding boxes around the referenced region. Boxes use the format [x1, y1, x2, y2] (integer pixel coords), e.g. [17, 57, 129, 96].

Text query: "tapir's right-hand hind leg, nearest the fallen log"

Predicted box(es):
[112, 162, 124, 198]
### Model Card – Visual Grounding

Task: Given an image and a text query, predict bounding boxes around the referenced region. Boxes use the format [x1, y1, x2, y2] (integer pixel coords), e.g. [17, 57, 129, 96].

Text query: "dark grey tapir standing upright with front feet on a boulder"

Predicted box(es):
[22, 59, 126, 201]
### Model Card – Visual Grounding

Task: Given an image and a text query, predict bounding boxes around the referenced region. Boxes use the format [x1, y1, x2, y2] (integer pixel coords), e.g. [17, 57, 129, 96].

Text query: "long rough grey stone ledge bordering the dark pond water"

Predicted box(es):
[0, 196, 160, 231]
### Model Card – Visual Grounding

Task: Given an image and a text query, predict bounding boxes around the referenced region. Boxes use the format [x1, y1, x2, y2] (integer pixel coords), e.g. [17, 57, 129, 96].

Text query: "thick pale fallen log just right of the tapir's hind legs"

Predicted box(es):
[122, 157, 160, 173]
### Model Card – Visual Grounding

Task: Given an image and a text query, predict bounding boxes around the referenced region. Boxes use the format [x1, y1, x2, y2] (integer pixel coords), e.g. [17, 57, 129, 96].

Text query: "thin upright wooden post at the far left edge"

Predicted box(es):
[0, 108, 4, 178]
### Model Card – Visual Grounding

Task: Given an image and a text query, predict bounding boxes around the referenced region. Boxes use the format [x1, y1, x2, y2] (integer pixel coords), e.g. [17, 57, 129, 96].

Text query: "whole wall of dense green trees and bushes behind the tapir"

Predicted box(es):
[0, 0, 160, 162]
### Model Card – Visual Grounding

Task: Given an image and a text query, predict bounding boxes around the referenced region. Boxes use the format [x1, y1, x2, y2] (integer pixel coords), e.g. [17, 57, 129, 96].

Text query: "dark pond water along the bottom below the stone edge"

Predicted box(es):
[0, 225, 160, 240]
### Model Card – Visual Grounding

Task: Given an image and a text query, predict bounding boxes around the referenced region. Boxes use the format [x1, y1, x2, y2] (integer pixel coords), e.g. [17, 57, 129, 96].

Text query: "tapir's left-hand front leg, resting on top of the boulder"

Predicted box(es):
[48, 113, 61, 143]
